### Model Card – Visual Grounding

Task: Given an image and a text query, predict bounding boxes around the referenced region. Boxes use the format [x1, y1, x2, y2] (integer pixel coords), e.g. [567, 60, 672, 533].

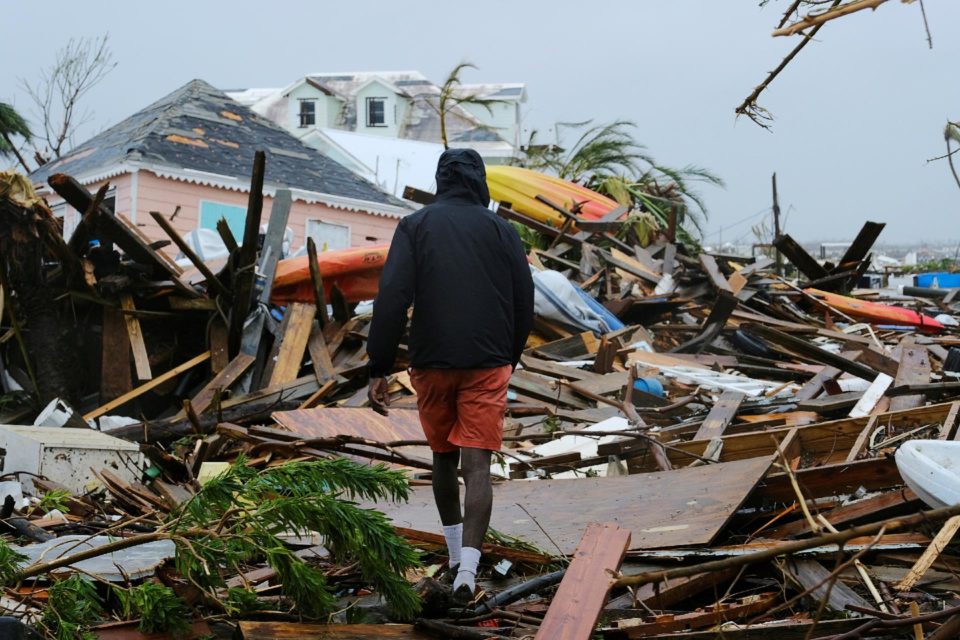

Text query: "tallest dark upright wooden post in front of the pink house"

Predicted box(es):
[229, 151, 266, 354]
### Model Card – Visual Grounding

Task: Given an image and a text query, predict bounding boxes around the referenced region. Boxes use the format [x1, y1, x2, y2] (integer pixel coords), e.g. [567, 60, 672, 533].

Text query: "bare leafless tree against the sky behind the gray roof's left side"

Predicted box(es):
[20, 34, 117, 158]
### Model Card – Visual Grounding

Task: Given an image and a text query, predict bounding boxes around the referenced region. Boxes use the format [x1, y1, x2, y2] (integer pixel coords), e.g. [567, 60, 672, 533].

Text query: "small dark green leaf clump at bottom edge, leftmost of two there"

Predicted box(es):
[41, 574, 103, 640]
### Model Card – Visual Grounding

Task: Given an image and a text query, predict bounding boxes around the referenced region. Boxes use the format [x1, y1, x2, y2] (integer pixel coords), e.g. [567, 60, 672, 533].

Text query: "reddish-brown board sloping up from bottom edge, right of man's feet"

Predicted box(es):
[536, 522, 630, 640]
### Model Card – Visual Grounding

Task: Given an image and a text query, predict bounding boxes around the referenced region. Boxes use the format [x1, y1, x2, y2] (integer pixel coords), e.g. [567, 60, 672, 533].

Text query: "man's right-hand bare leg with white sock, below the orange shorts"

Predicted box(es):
[453, 447, 493, 599]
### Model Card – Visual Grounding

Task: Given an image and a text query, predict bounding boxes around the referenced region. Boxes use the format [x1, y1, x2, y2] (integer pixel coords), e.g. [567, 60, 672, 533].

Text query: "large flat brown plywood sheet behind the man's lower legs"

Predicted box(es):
[368, 457, 771, 554]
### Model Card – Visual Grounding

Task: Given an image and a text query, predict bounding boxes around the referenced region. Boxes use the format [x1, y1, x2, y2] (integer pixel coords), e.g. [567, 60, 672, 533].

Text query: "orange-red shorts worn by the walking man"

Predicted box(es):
[410, 364, 513, 453]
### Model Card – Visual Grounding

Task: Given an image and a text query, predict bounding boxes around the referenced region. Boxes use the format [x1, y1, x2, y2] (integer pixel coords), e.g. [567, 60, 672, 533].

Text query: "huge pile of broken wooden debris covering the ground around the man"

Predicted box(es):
[0, 157, 960, 640]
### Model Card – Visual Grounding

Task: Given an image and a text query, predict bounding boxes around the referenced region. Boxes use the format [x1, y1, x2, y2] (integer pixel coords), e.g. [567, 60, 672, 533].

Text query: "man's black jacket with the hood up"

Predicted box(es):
[367, 149, 533, 377]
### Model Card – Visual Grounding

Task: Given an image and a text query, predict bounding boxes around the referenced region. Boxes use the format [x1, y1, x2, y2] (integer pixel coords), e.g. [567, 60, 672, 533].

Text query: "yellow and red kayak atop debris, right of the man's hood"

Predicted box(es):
[487, 165, 620, 227]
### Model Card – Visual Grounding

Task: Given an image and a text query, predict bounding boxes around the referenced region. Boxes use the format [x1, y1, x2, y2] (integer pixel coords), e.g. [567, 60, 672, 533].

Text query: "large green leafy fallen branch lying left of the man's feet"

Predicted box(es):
[170, 459, 420, 618]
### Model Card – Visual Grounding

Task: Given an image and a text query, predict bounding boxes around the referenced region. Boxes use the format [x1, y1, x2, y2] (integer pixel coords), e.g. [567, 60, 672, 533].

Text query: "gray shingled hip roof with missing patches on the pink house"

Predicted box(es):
[30, 80, 408, 208]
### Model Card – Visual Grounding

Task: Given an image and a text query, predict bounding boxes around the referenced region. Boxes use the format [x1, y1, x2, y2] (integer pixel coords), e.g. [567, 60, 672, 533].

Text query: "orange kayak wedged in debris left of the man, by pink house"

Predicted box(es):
[270, 244, 390, 305]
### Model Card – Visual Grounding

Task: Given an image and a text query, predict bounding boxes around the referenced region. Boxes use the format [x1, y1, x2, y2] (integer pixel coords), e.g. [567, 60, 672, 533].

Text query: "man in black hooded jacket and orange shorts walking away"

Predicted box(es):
[367, 149, 533, 604]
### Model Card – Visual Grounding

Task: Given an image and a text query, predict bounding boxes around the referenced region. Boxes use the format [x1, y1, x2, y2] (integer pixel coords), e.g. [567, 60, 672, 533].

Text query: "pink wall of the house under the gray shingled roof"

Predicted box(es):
[47, 170, 400, 255]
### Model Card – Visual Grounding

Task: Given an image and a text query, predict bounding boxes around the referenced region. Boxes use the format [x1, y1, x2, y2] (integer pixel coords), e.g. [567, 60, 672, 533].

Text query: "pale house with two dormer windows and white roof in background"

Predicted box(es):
[226, 71, 527, 165]
